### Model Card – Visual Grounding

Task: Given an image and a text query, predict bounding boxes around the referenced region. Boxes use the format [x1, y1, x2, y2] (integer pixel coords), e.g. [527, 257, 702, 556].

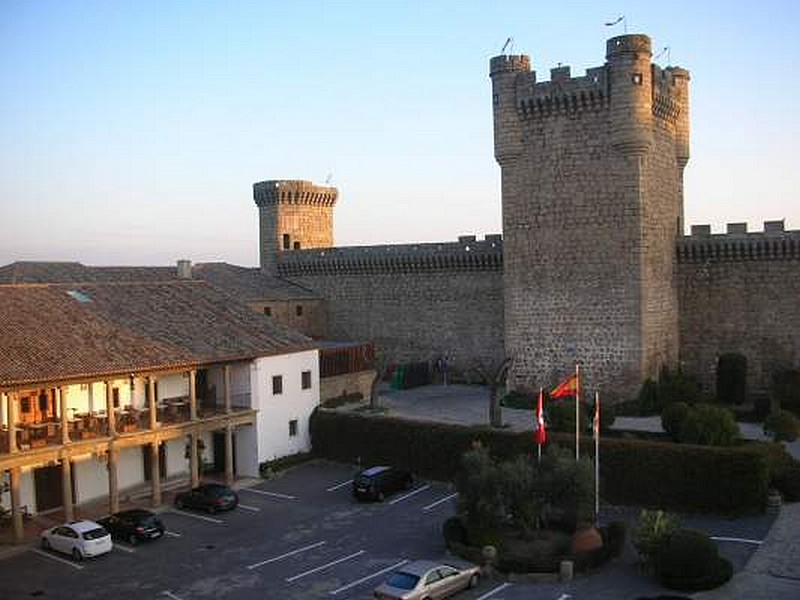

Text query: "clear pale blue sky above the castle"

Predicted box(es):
[0, 0, 800, 265]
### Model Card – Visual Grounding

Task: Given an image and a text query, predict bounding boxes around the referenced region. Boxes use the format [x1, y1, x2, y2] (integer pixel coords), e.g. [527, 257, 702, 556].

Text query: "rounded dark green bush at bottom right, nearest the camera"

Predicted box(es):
[654, 529, 733, 592]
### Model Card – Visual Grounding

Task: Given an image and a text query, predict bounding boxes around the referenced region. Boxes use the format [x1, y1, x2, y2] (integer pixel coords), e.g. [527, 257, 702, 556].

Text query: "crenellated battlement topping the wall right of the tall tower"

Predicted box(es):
[677, 221, 800, 263]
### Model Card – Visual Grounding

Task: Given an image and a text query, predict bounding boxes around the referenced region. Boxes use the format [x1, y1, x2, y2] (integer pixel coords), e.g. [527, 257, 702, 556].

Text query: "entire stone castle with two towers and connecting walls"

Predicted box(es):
[253, 35, 800, 397]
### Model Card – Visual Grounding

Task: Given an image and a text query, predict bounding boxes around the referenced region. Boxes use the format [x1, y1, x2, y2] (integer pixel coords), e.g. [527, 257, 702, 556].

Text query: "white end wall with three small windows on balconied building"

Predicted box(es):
[250, 350, 319, 463]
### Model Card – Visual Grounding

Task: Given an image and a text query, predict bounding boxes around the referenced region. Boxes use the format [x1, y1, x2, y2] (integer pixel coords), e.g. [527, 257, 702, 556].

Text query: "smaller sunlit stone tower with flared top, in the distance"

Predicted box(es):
[253, 180, 339, 273]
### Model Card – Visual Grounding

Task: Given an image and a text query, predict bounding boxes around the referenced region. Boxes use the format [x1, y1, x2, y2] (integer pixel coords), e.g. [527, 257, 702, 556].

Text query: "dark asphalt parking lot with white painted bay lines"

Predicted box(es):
[0, 461, 768, 600]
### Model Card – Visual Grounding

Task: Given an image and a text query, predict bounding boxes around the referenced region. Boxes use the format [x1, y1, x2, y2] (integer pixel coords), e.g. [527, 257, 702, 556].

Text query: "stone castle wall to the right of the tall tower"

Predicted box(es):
[678, 226, 800, 394]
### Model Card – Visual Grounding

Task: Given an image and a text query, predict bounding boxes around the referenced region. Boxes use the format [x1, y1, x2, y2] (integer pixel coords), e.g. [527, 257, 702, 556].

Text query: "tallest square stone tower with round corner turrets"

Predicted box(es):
[490, 35, 689, 394]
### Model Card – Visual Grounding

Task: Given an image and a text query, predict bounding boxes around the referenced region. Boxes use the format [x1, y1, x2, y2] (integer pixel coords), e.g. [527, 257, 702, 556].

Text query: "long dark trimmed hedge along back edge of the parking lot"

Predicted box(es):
[311, 409, 769, 514]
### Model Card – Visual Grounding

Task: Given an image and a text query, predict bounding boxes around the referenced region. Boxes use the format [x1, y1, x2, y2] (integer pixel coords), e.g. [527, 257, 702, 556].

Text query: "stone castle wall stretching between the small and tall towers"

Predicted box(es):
[279, 236, 503, 372]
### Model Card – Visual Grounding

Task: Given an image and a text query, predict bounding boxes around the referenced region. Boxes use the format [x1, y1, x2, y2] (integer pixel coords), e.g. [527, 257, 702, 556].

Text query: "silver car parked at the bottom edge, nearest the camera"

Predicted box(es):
[373, 560, 480, 600]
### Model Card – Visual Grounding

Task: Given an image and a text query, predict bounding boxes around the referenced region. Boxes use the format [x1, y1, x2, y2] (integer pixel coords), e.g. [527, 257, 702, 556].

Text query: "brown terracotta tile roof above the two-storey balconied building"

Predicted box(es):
[0, 281, 315, 386]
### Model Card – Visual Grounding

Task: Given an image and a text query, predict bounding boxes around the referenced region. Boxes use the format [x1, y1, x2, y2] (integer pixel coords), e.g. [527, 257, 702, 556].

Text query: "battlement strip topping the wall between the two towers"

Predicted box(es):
[278, 234, 503, 277]
